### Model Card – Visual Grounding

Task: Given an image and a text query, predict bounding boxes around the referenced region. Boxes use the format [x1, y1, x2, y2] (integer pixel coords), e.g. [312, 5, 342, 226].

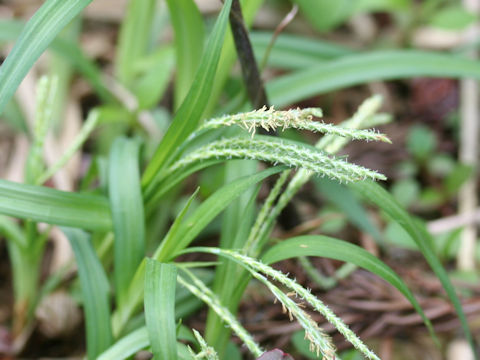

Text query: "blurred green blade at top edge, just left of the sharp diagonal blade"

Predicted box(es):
[167, 0, 205, 109]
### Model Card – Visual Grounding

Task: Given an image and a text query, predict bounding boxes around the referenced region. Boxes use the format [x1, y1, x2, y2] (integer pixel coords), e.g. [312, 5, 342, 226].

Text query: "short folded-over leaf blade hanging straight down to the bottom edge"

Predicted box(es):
[144, 259, 177, 360]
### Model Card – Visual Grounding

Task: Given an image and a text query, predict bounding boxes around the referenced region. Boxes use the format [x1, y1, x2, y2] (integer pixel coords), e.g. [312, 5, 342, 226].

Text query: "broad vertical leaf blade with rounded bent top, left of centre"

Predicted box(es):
[108, 137, 145, 304]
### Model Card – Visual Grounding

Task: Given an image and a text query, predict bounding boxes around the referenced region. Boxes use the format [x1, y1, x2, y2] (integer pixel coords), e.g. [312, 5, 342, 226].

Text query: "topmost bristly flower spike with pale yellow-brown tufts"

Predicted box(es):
[200, 106, 390, 142]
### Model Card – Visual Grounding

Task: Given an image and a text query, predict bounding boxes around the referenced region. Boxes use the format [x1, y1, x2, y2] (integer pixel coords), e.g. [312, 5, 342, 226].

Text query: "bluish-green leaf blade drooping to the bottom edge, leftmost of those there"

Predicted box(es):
[63, 228, 113, 360]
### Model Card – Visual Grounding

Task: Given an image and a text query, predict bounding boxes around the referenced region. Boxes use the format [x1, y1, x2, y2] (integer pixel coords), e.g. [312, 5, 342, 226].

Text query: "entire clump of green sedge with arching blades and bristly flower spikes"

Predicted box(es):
[0, 0, 480, 360]
